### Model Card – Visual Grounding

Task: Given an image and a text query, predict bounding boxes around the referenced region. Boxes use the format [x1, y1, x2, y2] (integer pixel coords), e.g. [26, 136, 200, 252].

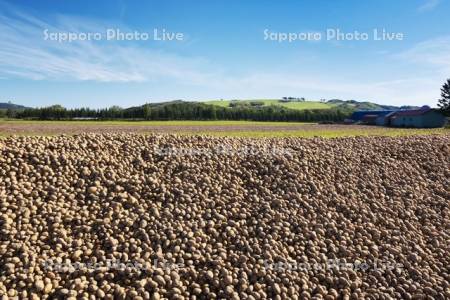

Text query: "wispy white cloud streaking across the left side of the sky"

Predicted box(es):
[0, 3, 213, 83]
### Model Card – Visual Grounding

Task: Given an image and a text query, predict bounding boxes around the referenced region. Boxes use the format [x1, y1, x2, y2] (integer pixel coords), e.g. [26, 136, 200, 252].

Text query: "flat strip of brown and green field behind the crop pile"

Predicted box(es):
[0, 121, 449, 137]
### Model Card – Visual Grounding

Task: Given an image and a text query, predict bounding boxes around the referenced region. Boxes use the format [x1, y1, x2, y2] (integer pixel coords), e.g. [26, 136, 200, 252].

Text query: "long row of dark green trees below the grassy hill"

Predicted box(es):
[14, 101, 351, 122]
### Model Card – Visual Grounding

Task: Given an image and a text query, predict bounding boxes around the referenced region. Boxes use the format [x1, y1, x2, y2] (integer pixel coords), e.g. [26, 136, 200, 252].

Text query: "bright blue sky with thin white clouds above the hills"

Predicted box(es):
[0, 0, 450, 108]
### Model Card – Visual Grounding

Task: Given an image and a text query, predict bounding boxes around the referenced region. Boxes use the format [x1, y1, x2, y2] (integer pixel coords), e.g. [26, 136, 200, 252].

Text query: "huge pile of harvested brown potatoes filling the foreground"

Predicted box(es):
[0, 134, 450, 299]
